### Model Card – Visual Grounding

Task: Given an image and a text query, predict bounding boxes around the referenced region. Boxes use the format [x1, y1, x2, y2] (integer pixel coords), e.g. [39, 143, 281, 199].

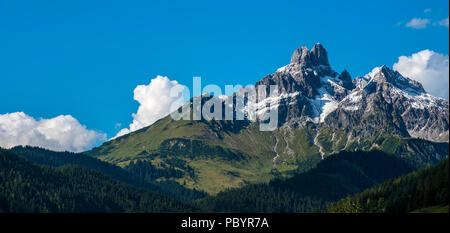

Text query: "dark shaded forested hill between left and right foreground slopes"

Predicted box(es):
[195, 151, 413, 212]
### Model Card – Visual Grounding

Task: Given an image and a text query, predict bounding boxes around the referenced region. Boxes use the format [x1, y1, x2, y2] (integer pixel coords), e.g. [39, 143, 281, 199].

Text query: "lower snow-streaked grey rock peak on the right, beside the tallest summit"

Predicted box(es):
[353, 66, 449, 142]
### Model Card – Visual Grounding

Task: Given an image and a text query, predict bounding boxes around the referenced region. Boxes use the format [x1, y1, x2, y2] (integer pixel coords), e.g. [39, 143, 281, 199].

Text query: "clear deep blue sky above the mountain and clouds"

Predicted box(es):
[0, 0, 449, 141]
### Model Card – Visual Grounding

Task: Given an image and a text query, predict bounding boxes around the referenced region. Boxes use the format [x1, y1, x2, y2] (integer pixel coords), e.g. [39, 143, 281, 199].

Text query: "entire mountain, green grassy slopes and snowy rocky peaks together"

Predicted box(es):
[84, 44, 449, 194]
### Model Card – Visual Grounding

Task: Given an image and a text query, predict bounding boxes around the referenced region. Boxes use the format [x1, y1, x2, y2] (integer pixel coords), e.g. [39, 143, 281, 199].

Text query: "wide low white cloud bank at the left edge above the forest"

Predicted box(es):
[0, 112, 106, 152]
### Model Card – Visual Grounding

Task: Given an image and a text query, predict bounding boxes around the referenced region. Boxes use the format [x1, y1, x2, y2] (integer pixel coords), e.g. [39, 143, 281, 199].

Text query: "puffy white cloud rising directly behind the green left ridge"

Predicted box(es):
[114, 75, 183, 138]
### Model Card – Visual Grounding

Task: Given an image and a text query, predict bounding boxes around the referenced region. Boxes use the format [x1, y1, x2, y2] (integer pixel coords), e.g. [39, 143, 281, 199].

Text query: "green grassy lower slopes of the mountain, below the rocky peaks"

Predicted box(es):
[84, 116, 448, 194]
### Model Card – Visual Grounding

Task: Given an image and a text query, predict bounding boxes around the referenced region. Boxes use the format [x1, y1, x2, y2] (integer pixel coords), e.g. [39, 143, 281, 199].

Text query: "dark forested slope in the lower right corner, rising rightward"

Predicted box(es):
[326, 159, 450, 213]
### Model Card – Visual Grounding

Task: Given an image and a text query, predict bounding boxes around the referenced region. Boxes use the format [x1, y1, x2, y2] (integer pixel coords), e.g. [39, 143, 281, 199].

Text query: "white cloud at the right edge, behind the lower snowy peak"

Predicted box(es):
[394, 49, 449, 99]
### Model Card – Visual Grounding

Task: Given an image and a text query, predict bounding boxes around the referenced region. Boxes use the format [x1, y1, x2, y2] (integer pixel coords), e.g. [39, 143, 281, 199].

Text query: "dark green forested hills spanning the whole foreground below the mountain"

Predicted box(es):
[0, 147, 449, 213]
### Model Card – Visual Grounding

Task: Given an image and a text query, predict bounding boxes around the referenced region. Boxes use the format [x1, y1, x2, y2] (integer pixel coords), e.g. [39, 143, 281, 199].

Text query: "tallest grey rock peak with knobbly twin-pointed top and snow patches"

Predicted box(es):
[255, 44, 348, 126]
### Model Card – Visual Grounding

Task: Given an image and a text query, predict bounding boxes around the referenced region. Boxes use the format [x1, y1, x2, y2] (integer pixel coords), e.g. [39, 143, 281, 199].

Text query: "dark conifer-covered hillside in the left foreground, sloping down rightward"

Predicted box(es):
[0, 149, 195, 213]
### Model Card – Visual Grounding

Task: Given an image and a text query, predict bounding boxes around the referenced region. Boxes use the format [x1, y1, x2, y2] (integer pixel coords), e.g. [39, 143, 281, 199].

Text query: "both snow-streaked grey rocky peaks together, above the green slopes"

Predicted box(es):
[248, 44, 449, 141]
